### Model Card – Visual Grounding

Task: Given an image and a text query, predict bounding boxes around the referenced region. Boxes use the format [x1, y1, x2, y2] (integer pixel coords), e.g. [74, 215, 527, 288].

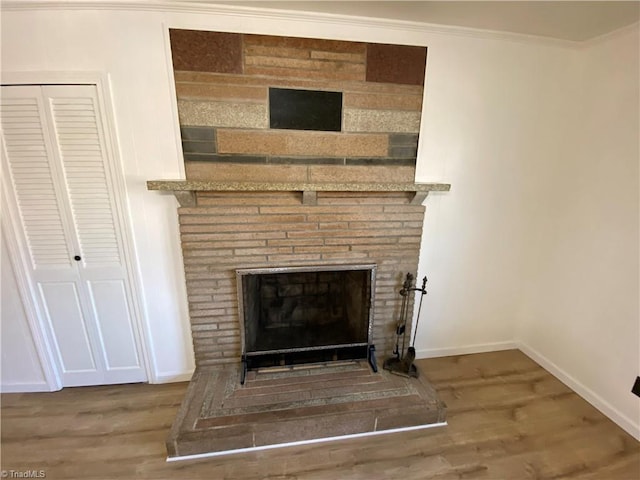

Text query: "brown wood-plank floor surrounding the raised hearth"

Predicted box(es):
[1, 350, 640, 480]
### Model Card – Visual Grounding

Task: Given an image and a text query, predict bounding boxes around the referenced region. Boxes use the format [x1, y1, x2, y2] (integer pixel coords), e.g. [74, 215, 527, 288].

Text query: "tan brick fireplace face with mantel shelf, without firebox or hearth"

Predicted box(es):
[149, 181, 449, 366]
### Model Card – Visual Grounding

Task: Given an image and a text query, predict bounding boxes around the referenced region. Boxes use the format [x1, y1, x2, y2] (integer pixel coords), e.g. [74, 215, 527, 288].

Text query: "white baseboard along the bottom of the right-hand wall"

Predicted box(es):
[516, 342, 640, 440]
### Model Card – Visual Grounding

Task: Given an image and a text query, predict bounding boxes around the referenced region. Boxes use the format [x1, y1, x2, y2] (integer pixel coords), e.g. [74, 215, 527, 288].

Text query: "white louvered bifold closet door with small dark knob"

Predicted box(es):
[0, 85, 146, 386]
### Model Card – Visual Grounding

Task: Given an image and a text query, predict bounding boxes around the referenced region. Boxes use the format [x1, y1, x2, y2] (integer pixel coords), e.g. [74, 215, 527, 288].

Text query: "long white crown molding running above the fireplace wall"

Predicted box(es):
[0, 0, 584, 49]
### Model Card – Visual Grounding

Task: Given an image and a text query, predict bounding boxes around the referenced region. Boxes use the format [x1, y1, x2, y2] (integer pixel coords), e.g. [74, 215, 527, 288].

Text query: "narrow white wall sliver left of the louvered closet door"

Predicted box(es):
[0, 232, 49, 392]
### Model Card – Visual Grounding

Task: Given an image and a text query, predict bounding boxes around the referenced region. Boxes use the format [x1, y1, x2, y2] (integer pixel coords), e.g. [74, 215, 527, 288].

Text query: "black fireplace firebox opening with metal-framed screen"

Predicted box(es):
[236, 265, 377, 379]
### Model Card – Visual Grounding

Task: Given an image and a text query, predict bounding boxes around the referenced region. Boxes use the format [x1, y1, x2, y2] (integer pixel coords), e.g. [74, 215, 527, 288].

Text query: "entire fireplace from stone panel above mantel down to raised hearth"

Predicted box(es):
[147, 29, 449, 457]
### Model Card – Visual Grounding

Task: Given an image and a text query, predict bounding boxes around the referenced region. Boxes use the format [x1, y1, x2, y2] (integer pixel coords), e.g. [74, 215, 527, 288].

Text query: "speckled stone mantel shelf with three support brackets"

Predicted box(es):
[147, 180, 451, 207]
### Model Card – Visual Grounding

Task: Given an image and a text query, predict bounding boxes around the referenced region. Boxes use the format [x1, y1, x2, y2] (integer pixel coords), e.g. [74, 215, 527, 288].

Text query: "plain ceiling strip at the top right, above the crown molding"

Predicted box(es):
[215, 1, 640, 42]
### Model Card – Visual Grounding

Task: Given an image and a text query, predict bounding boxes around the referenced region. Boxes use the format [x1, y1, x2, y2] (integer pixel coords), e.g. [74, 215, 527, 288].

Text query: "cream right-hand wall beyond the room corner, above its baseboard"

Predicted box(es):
[517, 26, 640, 438]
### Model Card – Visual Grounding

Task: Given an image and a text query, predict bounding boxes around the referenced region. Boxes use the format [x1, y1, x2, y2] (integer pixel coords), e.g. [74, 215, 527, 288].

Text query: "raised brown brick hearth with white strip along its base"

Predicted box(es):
[166, 361, 446, 459]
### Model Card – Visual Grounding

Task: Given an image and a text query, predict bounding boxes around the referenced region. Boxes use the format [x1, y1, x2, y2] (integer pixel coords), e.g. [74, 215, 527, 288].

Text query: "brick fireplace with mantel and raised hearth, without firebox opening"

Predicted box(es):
[147, 180, 449, 460]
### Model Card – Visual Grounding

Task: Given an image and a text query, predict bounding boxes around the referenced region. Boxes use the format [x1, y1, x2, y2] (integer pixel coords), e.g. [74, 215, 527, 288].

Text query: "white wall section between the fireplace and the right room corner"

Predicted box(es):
[416, 33, 575, 357]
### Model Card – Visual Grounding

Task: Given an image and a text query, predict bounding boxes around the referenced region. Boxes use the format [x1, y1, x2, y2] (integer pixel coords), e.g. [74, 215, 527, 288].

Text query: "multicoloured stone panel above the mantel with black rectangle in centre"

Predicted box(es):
[169, 28, 427, 183]
